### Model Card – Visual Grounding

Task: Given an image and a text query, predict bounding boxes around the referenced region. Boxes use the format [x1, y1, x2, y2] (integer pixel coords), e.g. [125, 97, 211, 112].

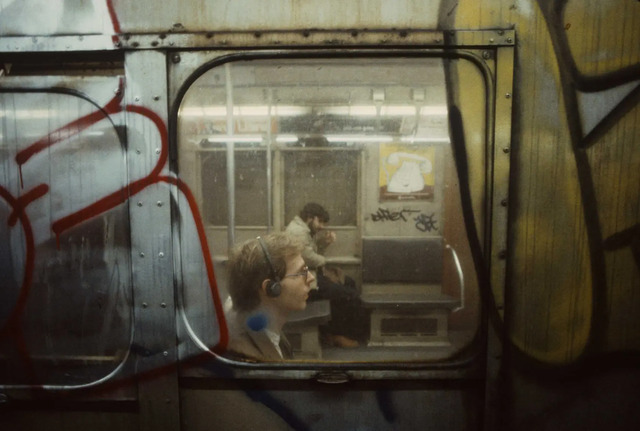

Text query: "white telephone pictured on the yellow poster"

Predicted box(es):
[383, 152, 433, 193]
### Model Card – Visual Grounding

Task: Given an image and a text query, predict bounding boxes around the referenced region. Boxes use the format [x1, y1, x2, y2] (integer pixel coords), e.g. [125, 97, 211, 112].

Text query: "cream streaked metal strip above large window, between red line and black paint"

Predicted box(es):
[113, 0, 441, 33]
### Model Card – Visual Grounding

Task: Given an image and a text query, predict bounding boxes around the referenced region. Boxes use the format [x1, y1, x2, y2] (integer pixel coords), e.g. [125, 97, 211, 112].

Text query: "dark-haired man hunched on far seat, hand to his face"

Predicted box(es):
[285, 202, 369, 347]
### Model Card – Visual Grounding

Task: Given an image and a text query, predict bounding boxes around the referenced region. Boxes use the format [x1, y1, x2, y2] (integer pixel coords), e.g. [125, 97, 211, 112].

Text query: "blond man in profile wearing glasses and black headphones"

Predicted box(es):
[228, 232, 315, 361]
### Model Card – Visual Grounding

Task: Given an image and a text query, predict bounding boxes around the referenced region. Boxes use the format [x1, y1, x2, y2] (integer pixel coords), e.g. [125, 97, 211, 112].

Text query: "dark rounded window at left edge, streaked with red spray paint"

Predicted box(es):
[0, 90, 132, 388]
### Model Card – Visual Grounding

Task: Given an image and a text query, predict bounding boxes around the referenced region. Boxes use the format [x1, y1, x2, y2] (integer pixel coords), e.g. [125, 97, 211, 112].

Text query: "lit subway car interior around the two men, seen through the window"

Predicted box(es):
[172, 57, 483, 361]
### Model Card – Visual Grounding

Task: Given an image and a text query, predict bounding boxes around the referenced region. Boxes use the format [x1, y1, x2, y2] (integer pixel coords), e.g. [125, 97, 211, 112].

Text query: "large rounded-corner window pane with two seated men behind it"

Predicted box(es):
[178, 57, 487, 363]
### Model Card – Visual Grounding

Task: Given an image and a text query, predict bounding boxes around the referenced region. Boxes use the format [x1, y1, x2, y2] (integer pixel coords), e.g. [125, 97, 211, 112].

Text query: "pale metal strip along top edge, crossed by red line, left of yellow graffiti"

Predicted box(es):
[0, 0, 441, 36]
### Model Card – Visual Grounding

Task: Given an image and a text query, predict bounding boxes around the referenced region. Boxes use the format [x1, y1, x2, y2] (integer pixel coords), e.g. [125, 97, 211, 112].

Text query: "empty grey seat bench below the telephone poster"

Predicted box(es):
[361, 236, 460, 346]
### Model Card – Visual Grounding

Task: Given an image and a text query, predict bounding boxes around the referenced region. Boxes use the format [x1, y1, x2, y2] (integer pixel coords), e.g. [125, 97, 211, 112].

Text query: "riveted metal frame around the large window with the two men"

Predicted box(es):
[169, 30, 515, 381]
